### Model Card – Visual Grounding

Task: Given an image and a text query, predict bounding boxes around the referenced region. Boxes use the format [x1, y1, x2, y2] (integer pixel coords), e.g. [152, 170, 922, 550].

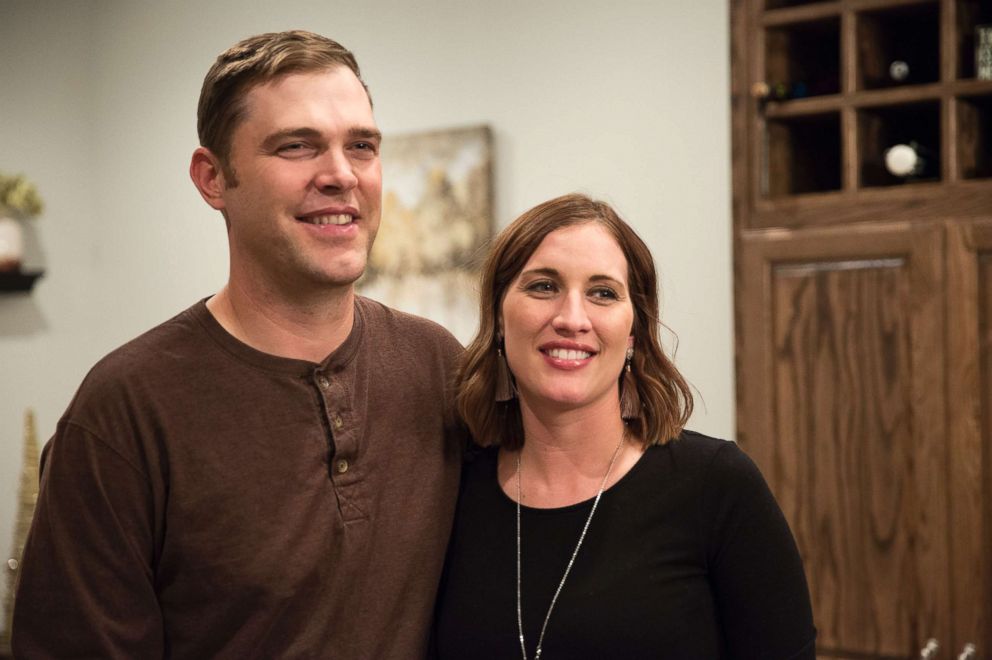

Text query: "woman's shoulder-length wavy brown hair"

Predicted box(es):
[456, 194, 692, 450]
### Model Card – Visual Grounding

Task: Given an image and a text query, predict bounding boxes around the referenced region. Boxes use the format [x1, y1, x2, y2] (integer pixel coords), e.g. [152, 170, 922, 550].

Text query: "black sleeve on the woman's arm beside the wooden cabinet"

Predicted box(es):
[702, 442, 816, 660]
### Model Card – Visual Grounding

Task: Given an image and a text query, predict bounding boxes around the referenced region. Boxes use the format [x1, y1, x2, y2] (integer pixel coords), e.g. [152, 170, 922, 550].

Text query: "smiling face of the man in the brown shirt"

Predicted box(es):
[215, 67, 382, 294]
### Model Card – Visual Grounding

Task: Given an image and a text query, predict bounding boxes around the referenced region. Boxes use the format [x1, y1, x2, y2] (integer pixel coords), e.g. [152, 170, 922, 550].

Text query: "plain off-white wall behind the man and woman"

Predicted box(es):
[0, 0, 734, 628]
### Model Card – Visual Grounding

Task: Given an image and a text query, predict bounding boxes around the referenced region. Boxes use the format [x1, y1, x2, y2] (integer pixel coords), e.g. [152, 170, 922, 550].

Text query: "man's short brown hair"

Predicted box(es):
[196, 30, 372, 180]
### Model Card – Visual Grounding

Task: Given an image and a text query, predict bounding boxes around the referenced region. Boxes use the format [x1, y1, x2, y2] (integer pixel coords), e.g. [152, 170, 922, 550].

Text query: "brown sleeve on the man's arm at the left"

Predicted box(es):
[11, 420, 163, 658]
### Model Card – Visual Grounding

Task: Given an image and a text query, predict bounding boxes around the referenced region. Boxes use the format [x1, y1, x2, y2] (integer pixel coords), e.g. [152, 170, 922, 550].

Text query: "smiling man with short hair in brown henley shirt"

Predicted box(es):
[13, 32, 460, 659]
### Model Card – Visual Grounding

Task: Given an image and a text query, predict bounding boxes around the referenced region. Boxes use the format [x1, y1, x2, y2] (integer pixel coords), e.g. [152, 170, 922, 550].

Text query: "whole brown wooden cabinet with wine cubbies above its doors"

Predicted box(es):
[731, 0, 992, 659]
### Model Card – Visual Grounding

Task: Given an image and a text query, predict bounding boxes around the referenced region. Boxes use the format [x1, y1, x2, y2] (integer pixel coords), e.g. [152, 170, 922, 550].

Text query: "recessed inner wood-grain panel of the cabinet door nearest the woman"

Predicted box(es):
[771, 259, 920, 653]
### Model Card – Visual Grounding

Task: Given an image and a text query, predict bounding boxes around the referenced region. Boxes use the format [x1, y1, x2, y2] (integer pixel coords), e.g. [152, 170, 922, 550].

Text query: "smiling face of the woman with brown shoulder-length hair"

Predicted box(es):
[500, 222, 634, 414]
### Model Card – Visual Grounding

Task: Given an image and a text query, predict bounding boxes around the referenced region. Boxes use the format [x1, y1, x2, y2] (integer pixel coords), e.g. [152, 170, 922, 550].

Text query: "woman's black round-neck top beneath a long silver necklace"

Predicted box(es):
[435, 431, 816, 660]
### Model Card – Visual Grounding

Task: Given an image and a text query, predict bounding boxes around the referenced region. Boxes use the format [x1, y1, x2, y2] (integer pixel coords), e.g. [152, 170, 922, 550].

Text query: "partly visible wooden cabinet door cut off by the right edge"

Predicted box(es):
[947, 220, 992, 658]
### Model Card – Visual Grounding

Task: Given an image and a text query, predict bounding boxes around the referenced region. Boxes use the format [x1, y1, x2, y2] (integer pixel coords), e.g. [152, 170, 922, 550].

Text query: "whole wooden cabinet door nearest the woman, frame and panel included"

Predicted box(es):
[738, 225, 949, 658]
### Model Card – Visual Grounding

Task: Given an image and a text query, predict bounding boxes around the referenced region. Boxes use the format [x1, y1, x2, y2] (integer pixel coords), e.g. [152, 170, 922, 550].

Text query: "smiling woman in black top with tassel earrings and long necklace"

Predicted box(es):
[436, 195, 815, 660]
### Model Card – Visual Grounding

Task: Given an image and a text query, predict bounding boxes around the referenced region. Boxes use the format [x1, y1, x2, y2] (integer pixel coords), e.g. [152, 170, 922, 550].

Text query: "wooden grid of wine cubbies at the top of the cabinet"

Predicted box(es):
[748, 0, 992, 209]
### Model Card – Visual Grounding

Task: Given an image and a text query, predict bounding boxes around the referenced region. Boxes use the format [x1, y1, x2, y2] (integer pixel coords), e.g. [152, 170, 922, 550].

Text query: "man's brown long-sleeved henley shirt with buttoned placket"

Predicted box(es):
[12, 298, 462, 660]
